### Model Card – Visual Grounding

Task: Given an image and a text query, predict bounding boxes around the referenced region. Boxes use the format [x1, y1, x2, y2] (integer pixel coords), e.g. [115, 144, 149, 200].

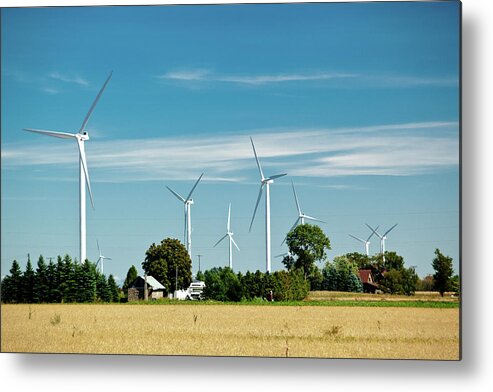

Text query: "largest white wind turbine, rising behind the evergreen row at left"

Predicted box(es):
[24, 72, 113, 263]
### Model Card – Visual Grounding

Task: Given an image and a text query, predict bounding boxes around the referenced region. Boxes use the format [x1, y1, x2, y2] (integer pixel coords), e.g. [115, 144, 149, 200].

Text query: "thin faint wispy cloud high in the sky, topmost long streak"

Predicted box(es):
[157, 69, 458, 88]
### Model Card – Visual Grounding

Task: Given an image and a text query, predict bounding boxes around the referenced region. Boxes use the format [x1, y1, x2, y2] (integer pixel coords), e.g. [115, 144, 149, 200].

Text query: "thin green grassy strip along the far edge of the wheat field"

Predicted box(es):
[128, 299, 459, 309]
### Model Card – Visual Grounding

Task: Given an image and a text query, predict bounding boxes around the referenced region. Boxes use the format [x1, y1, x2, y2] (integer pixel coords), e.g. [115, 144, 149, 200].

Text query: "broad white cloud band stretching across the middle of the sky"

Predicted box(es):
[2, 122, 459, 182]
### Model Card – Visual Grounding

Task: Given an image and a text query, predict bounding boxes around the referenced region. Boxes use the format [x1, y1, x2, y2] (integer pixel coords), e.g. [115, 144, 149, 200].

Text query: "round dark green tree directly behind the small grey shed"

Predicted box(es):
[142, 238, 192, 291]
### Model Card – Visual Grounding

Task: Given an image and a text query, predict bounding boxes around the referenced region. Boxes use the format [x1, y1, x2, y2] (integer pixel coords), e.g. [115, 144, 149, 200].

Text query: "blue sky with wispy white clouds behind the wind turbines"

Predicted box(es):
[1, 2, 459, 278]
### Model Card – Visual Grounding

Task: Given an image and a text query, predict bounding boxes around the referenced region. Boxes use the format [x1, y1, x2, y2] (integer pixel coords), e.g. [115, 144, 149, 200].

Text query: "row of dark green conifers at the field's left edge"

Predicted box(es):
[1, 255, 120, 303]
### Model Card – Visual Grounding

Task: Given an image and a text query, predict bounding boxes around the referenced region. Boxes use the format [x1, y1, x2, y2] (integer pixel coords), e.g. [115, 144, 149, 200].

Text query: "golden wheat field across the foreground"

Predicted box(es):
[1, 304, 459, 360]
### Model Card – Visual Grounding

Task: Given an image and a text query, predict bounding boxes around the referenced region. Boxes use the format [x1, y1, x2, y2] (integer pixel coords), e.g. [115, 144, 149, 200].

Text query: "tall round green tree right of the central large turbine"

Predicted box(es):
[286, 224, 330, 279]
